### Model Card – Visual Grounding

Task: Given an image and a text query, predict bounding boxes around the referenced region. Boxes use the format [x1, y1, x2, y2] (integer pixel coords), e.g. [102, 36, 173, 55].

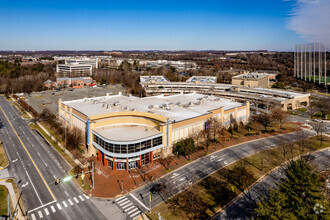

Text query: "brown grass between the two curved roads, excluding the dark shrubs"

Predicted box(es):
[147, 137, 330, 220]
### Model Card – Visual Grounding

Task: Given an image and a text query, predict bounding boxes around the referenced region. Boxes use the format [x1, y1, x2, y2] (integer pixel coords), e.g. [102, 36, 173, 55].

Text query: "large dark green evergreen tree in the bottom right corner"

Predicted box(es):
[255, 159, 329, 220]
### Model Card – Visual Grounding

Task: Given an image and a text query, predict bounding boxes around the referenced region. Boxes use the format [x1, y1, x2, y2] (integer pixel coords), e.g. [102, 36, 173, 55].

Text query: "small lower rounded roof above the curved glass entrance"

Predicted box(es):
[94, 125, 161, 141]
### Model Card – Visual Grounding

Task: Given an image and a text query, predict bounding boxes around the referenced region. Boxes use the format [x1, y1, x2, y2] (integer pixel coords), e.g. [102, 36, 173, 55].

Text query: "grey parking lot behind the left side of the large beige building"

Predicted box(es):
[24, 85, 124, 115]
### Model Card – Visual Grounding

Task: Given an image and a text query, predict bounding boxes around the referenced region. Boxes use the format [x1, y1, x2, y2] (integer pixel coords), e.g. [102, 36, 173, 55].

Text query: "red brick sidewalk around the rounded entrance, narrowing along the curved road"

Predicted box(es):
[83, 123, 302, 198]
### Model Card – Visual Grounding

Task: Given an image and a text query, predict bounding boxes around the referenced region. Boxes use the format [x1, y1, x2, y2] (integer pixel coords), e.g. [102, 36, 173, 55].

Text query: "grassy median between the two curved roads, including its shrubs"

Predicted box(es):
[147, 137, 330, 220]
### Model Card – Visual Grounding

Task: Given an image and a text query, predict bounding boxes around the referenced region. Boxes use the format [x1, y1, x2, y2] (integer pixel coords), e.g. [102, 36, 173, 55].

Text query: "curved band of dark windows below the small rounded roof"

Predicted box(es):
[93, 134, 163, 154]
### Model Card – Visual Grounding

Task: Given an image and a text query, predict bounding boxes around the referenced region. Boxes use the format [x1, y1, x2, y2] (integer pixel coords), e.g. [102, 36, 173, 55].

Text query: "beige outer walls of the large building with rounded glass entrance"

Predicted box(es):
[59, 100, 250, 157]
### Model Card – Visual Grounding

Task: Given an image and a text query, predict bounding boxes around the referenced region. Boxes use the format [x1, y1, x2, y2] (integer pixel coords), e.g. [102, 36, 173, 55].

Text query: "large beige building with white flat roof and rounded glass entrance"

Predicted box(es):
[58, 93, 250, 170]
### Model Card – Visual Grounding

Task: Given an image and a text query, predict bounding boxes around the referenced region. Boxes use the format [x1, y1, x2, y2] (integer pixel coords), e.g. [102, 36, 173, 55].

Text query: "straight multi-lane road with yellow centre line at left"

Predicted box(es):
[0, 96, 106, 220]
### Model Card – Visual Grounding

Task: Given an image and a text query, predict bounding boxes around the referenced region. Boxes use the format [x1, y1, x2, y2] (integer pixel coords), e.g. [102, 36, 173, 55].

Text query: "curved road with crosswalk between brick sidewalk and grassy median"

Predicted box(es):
[115, 127, 330, 219]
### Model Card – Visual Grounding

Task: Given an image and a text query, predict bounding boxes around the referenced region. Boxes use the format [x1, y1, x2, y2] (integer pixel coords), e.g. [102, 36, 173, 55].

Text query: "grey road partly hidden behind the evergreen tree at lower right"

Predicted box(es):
[212, 149, 330, 220]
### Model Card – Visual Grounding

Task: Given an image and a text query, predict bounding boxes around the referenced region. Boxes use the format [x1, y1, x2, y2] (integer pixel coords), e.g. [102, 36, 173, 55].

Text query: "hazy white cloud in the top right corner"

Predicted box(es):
[288, 0, 330, 48]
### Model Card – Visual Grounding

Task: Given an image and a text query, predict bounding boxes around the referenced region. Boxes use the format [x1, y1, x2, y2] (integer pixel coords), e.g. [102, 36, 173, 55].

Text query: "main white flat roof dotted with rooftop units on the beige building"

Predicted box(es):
[63, 93, 244, 121]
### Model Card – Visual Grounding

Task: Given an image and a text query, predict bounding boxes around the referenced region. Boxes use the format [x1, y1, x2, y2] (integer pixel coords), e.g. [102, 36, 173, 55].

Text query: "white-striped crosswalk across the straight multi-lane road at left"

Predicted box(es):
[29, 194, 89, 220]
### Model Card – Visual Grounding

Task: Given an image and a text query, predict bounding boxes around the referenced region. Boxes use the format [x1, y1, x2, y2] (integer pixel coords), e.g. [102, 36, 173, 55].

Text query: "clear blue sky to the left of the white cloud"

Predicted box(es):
[0, 0, 316, 50]
